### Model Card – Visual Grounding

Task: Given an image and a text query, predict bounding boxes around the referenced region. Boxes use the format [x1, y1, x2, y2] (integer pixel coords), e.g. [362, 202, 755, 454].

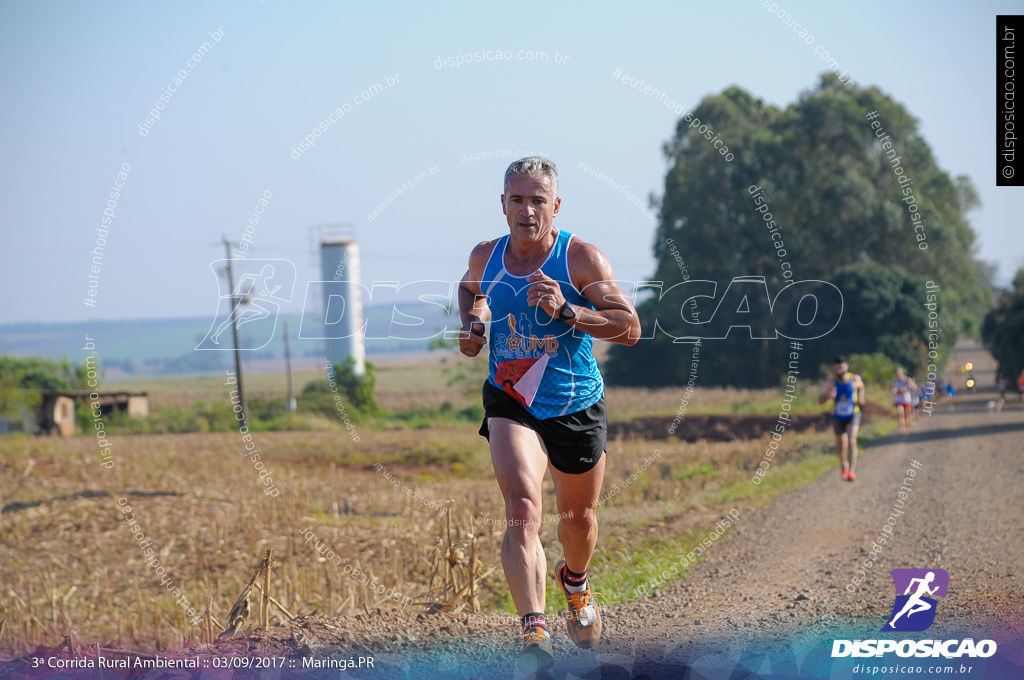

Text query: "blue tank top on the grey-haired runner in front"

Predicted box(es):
[480, 231, 604, 420]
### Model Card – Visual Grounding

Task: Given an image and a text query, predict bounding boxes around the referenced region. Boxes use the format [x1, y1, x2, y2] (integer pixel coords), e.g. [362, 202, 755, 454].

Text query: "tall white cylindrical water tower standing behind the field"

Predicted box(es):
[315, 224, 367, 376]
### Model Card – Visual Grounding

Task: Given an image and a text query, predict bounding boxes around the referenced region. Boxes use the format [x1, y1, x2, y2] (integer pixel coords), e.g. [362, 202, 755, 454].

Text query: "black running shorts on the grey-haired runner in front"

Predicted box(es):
[480, 380, 608, 474]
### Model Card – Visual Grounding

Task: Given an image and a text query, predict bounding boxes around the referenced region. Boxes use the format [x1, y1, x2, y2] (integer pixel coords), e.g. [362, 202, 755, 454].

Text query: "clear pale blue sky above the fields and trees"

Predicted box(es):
[0, 0, 1024, 323]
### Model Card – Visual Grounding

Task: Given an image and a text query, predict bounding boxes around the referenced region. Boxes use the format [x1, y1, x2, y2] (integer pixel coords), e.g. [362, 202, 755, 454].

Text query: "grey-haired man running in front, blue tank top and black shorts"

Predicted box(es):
[459, 157, 640, 672]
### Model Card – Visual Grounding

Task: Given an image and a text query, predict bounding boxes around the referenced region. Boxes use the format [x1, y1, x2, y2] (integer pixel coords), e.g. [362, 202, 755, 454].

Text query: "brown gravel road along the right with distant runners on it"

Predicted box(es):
[608, 346, 1024, 677]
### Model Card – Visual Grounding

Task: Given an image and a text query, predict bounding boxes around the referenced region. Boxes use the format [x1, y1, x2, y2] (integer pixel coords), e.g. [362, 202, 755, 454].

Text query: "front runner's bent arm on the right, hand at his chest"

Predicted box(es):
[526, 238, 641, 345]
